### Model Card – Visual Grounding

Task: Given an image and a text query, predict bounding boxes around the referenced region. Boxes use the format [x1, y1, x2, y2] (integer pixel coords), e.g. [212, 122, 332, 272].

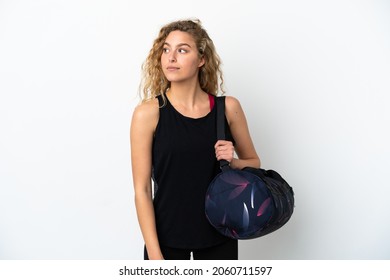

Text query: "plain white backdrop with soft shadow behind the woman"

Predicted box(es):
[0, 0, 390, 259]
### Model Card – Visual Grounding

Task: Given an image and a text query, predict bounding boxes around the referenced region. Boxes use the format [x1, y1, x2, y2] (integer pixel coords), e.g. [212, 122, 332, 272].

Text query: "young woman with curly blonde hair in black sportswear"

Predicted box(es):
[130, 20, 260, 259]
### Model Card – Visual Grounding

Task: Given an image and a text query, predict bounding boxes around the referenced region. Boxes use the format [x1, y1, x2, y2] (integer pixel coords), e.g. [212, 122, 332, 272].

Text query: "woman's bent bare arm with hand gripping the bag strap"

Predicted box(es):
[215, 96, 260, 169]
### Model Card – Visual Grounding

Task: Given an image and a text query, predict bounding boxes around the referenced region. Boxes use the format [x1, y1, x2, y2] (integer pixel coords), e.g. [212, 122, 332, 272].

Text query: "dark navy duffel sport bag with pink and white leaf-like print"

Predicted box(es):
[205, 97, 294, 239]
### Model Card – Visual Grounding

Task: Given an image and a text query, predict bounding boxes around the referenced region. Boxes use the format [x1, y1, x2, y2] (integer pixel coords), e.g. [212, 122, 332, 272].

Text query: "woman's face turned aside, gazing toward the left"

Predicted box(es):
[161, 31, 204, 83]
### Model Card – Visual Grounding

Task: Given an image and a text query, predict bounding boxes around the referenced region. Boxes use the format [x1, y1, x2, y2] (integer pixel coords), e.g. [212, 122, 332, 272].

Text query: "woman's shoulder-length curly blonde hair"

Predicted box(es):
[140, 19, 225, 102]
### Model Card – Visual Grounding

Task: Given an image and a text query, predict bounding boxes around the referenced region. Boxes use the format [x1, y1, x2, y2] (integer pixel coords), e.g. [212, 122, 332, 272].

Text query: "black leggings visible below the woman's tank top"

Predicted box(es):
[144, 239, 238, 260]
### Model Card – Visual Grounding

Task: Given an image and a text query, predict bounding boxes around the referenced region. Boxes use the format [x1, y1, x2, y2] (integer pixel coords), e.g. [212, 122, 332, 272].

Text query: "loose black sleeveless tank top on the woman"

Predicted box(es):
[152, 96, 234, 249]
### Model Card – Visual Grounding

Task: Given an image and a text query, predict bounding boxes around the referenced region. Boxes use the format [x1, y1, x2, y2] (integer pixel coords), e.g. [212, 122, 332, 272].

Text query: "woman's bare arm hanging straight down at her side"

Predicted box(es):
[130, 99, 163, 260]
